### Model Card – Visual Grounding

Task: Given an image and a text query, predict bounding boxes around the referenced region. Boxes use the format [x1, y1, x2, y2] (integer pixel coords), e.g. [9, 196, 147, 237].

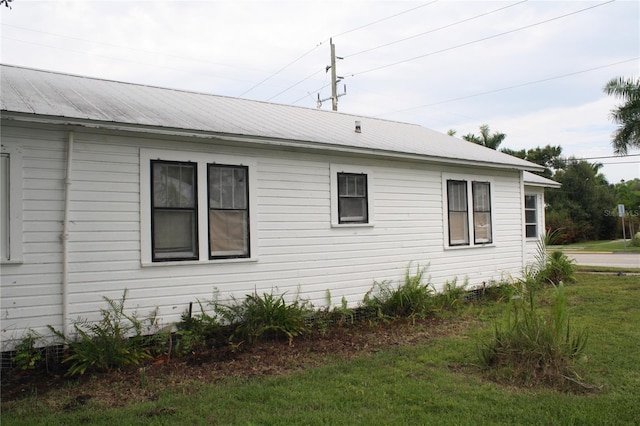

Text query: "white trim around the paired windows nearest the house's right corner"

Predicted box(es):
[441, 172, 496, 250]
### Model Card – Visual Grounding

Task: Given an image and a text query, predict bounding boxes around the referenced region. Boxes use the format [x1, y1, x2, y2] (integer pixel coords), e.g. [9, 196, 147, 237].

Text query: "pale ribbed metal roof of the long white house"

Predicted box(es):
[0, 65, 542, 170]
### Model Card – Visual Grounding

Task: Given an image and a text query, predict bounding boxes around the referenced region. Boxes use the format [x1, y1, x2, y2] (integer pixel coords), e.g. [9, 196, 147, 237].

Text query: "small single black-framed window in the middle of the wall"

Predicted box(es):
[338, 173, 369, 223]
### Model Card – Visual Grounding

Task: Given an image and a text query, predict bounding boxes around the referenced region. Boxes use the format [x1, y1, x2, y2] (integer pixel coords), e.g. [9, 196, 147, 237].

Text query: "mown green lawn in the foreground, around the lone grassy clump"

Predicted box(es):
[1, 274, 640, 426]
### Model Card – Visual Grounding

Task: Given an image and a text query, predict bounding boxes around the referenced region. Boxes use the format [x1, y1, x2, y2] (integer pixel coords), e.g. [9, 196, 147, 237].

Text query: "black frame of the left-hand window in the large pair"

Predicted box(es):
[150, 160, 200, 262]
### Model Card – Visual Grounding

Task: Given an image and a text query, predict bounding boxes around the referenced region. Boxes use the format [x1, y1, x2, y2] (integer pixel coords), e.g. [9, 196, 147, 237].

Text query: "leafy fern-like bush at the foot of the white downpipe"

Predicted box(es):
[50, 290, 158, 375]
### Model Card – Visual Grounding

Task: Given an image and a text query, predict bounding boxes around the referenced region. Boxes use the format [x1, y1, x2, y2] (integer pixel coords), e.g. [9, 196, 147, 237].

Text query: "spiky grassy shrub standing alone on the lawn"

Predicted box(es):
[478, 282, 587, 384]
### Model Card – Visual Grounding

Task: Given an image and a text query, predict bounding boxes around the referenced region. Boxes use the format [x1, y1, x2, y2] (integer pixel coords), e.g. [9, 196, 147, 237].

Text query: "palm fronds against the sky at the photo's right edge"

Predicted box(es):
[604, 77, 640, 155]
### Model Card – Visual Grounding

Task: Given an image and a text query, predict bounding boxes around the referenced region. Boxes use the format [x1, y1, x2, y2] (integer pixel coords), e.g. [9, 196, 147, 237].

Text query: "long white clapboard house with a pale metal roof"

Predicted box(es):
[0, 65, 555, 349]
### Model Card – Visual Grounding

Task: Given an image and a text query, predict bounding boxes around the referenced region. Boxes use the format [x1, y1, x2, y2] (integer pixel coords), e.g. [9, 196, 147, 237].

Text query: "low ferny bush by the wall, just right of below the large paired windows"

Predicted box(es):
[216, 293, 312, 343]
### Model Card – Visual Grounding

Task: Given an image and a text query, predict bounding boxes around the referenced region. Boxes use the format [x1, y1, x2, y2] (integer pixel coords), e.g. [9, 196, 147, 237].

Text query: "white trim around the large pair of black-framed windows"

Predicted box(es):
[140, 148, 258, 266]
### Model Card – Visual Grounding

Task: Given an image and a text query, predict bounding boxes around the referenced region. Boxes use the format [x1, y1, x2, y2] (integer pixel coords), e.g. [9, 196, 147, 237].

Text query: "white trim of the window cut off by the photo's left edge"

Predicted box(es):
[0, 145, 23, 264]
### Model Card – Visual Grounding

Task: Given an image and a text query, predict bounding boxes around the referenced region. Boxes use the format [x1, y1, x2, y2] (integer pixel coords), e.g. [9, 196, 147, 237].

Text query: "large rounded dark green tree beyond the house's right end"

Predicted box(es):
[545, 158, 617, 243]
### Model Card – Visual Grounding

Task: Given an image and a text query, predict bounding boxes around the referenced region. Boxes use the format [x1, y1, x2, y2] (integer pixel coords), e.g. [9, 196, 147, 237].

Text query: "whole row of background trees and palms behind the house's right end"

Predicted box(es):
[448, 77, 640, 243]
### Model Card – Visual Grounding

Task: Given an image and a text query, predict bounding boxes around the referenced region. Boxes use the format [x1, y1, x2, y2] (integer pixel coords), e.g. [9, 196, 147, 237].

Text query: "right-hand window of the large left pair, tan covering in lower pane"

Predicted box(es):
[207, 164, 249, 259]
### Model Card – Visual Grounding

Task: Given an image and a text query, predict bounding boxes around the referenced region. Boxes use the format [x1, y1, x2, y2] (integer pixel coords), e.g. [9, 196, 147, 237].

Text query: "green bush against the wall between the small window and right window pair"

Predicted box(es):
[363, 265, 435, 318]
